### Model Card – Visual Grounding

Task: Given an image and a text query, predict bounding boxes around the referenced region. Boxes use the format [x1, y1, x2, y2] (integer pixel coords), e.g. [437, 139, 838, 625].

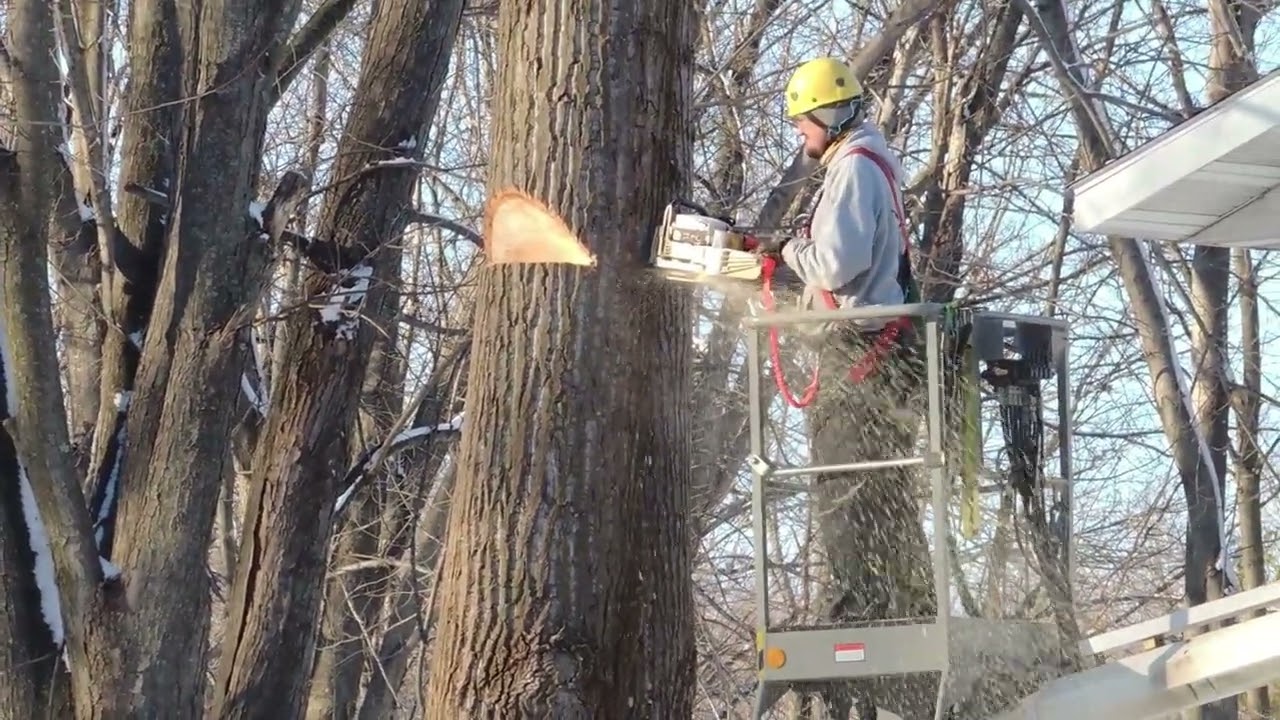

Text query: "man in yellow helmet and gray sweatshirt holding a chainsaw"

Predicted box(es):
[756, 58, 937, 720]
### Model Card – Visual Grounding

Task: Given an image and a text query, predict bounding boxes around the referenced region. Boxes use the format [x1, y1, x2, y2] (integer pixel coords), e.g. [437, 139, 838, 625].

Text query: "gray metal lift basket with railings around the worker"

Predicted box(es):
[744, 304, 1074, 720]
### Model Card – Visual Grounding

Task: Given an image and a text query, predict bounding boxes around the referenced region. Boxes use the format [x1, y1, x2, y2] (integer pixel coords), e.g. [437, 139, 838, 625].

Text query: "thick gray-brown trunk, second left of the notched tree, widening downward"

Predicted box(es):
[97, 0, 301, 717]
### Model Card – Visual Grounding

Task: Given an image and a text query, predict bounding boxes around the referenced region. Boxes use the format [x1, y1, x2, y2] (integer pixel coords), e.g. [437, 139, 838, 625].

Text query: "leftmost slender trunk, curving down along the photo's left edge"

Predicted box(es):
[0, 0, 112, 717]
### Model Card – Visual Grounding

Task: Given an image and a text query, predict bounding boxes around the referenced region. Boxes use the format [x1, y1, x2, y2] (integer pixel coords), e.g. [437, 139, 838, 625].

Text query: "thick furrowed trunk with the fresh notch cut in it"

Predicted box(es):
[425, 0, 696, 720]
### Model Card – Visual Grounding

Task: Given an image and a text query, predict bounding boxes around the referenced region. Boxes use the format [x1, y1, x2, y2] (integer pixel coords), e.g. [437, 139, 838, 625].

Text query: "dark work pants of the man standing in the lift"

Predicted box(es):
[806, 324, 938, 720]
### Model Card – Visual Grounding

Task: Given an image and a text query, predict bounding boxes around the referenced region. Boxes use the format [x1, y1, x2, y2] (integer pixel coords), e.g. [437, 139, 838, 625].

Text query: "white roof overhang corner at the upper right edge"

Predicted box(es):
[1073, 70, 1280, 249]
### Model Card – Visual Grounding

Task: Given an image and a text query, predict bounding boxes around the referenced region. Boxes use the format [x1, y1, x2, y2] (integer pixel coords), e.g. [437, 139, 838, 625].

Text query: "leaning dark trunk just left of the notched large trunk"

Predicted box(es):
[215, 0, 463, 717]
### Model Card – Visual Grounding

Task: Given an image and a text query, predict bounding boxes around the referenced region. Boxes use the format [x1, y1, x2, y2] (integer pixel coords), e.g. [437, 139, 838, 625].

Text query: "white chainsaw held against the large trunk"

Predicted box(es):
[649, 200, 785, 284]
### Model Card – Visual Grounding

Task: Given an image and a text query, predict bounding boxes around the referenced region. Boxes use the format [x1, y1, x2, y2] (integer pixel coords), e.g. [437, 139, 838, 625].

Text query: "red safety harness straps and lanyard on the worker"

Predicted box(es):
[746, 147, 911, 409]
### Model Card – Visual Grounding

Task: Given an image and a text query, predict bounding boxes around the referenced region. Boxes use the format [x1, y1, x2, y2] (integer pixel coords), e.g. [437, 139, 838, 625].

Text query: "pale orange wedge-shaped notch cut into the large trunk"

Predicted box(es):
[484, 188, 595, 268]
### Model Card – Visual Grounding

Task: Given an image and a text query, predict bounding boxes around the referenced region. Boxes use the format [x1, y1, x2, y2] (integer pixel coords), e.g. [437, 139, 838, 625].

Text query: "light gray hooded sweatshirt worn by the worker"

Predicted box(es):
[782, 120, 904, 331]
